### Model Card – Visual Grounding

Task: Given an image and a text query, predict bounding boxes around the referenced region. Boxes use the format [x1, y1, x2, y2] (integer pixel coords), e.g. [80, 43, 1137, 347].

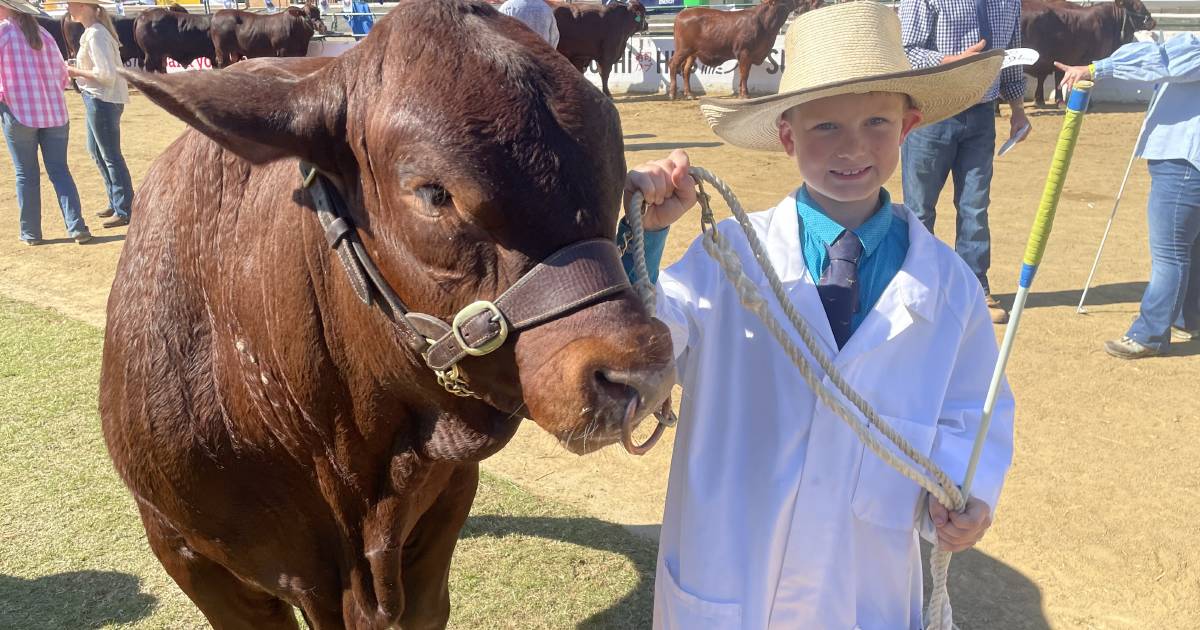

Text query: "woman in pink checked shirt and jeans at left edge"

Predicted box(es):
[0, 0, 91, 245]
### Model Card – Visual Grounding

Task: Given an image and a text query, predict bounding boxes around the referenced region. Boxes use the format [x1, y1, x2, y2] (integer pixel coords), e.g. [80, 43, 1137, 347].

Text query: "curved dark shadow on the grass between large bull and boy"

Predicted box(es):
[461, 515, 658, 630]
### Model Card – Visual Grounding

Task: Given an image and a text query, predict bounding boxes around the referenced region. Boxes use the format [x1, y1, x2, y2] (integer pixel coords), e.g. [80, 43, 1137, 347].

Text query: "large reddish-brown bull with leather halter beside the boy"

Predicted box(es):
[100, 0, 673, 630]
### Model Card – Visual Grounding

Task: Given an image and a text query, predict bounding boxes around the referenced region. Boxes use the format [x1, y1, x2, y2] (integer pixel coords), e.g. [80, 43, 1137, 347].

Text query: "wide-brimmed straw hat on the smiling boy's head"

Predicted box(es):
[700, 0, 1004, 151]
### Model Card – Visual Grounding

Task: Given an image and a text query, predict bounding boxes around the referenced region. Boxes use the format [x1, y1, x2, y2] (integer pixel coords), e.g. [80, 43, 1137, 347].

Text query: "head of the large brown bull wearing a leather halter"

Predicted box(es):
[128, 0, 673, 452]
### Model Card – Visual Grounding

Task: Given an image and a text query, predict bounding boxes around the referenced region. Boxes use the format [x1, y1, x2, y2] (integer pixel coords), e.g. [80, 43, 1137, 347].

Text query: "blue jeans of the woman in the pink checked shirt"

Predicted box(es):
[0, 103, 88, 241]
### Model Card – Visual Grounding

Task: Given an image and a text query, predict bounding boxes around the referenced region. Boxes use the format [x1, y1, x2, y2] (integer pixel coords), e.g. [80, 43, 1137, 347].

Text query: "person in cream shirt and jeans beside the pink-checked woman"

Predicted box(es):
[67, 0, 133, 228]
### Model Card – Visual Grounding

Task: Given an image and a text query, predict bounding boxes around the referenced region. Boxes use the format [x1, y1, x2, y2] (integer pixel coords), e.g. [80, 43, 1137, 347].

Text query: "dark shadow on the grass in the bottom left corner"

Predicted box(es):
[0, 571, 158, 630]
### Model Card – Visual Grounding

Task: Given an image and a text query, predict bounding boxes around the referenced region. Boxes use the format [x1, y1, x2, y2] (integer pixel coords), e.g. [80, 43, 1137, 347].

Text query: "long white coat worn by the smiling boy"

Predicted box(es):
[654, 196, 1013, 630]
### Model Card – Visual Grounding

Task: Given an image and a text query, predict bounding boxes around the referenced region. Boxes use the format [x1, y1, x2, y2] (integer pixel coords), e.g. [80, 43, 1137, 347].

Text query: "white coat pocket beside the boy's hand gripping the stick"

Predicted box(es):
[851, 415, 937, 529]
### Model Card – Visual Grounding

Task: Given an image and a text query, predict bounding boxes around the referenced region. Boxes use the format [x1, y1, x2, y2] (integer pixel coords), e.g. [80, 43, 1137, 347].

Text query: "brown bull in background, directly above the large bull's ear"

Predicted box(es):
[210, 6, 320, 67]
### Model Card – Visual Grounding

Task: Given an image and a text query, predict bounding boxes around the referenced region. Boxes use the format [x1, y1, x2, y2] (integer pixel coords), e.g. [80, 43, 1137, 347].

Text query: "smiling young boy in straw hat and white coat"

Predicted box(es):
[618, 2, 1013, 630]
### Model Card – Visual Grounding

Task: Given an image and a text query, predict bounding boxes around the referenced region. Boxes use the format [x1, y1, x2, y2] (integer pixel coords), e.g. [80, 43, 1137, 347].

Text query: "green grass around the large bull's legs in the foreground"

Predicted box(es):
[0, 299, 655, 630]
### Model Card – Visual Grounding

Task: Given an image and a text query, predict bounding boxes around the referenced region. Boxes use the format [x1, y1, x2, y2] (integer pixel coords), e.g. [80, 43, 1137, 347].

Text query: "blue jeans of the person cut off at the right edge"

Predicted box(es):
[1126, 160, 1200, 350]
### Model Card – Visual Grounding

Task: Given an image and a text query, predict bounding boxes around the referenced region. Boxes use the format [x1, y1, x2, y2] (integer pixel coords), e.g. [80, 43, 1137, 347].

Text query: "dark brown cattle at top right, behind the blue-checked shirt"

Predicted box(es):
[1021, 0, 1158, 107]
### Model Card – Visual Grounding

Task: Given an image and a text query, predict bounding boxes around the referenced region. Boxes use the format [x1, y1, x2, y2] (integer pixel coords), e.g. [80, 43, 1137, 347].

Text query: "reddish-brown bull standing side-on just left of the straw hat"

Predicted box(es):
[667, 0, 822, 100]
